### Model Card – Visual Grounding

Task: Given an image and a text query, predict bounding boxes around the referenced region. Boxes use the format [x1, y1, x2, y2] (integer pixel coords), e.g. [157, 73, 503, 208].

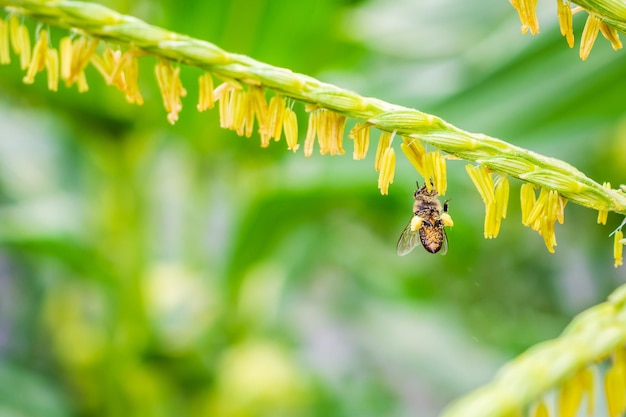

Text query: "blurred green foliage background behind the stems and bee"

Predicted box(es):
[0, 0, 626, 417]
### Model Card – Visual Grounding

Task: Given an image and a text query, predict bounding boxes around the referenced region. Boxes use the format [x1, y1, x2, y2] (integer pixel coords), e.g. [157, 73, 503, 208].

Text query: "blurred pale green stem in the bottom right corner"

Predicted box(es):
[441, 285, 626, 417]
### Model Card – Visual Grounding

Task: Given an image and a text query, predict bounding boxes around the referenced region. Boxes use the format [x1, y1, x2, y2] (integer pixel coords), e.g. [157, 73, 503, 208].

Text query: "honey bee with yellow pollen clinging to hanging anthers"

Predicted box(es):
[398, 183, 454, 256]
